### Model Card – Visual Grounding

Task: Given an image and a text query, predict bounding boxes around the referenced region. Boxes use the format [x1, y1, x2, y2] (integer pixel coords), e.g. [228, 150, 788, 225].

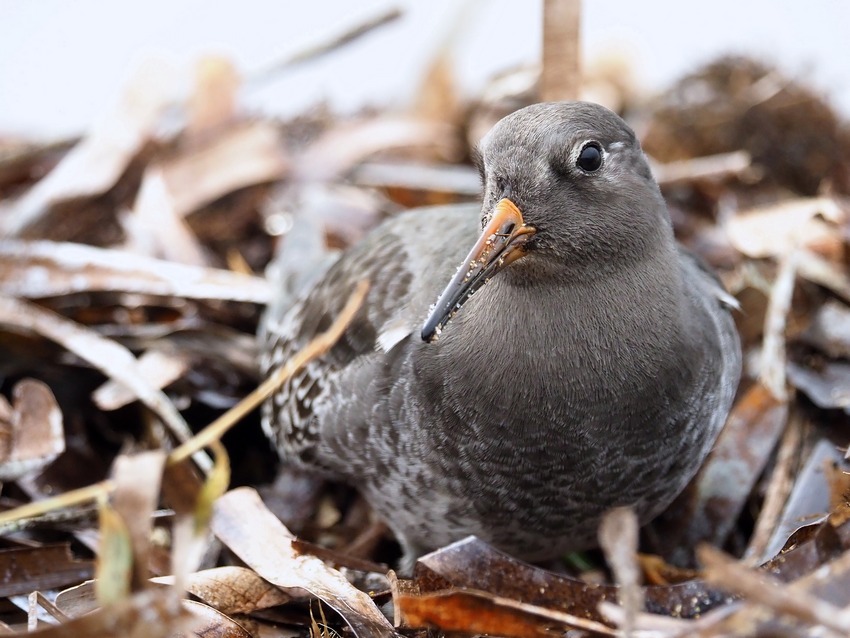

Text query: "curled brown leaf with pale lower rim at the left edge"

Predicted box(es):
[0, 379, 65, 481]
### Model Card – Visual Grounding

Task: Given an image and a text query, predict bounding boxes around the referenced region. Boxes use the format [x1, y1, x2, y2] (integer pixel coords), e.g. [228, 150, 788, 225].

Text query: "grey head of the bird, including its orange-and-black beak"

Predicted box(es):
[422, 102, 672, 341]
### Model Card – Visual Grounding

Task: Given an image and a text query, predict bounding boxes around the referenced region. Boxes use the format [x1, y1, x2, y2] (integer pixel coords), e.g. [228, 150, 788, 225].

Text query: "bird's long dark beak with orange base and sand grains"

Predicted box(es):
[422, 198, 535, 341]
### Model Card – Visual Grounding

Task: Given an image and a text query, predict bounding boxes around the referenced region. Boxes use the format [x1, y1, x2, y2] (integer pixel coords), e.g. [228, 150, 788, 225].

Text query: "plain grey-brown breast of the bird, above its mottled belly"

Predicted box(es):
[414, 281, 698, 451]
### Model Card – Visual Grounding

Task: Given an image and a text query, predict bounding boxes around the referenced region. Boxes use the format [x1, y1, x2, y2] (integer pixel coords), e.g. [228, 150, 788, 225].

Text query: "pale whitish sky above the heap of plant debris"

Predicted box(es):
[0, 0, 850, 138]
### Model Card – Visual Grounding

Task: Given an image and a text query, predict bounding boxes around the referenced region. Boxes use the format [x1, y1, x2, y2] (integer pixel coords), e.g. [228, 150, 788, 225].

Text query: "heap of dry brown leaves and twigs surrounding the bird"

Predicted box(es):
[0, 0, 850, 638]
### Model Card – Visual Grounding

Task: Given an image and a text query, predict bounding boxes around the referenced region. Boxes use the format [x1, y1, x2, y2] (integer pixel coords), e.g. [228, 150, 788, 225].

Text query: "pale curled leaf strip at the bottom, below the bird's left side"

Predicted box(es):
[212, 487, 397, 638]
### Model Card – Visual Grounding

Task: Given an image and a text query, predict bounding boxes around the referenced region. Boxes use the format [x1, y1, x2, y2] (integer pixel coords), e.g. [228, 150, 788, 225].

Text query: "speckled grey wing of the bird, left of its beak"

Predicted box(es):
[261, 205, 480, 465]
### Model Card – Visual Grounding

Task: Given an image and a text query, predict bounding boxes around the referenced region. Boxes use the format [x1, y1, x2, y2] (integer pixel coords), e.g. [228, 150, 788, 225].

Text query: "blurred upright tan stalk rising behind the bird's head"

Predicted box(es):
[540, 0, 581, 102]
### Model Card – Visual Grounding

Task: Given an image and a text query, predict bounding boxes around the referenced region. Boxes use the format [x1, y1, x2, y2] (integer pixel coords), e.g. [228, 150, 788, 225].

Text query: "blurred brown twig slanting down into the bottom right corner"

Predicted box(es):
[697, 545, 850, 636]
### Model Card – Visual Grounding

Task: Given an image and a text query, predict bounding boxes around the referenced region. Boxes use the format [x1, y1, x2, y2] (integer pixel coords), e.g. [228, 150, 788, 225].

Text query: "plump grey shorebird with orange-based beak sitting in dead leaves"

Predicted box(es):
[260, 102, 741, 565]
